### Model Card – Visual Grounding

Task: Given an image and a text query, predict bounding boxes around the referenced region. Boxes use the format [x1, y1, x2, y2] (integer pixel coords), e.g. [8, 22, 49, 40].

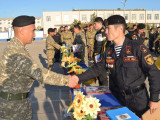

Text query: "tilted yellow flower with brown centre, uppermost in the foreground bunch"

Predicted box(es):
[73, 92, 85, 109]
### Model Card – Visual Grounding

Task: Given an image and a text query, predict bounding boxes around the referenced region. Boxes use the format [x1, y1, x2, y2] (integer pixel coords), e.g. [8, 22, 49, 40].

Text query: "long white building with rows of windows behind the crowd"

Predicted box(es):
[43, 9, 160, 35]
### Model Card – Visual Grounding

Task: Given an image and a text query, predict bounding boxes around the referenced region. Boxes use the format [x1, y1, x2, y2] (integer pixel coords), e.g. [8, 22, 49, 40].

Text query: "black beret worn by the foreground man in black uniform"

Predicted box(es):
[105, 15, 126, 26]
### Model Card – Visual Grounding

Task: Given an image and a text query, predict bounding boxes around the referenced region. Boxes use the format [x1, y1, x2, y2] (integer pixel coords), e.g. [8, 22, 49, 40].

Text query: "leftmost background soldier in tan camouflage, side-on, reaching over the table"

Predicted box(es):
[46, 28, 61, 70]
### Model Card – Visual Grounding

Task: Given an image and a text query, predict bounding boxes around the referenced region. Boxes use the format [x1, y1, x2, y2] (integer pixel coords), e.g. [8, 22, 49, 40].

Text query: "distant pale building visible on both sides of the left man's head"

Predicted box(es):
[0, 17, 43, 32]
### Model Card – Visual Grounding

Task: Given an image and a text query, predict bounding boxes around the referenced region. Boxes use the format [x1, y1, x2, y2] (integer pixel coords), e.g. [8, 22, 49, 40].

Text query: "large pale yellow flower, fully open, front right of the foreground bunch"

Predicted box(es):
[82, 97, 101, 116]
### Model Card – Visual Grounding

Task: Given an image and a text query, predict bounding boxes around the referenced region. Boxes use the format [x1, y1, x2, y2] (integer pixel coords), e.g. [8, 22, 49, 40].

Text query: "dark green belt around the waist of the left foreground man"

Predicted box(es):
[0, 91, 29, 101]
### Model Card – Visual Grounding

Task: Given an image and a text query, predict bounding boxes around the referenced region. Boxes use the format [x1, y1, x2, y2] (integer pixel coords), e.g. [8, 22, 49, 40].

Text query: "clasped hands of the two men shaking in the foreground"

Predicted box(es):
[68, 75, 79, 88]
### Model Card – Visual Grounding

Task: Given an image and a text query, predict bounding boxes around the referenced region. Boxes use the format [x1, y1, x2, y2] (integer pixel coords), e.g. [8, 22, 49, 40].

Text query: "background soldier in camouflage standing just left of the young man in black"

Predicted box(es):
[86, 24, 96, 57]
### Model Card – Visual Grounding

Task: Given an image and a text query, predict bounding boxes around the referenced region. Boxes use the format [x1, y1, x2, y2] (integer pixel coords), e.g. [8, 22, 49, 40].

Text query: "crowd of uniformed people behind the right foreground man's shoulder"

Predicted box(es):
[126, 23, 160, 55]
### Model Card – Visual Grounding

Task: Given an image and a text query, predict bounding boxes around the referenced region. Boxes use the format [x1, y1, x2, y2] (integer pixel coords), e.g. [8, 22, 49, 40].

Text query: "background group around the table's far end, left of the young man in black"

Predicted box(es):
[46, 24, 96, 70]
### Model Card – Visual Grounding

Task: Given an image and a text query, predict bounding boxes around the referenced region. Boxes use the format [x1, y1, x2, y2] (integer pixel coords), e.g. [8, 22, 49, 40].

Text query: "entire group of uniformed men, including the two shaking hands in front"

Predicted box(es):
[0, 15, 160, 120]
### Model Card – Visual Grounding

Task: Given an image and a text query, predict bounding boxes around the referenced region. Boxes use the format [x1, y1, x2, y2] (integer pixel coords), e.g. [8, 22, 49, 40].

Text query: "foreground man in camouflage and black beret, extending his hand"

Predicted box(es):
[0, 16, 77, 120]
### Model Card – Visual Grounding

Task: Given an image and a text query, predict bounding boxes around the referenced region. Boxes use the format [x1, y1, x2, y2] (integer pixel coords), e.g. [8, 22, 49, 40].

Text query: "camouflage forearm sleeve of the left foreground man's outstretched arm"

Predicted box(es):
[42, 68, 69, 86]
